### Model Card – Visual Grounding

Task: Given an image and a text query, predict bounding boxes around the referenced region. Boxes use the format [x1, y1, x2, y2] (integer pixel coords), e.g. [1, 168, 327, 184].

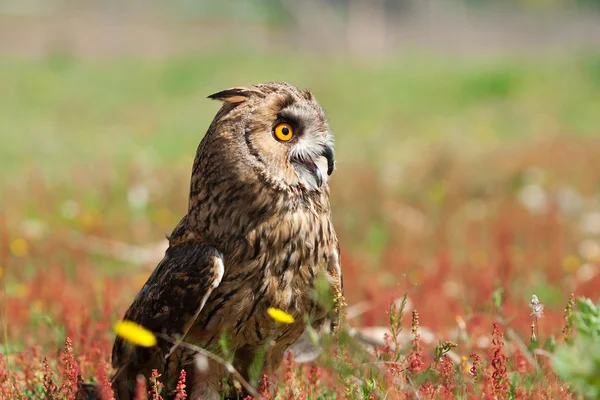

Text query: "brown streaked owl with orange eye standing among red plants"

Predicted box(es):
[112, 83, 342, 400]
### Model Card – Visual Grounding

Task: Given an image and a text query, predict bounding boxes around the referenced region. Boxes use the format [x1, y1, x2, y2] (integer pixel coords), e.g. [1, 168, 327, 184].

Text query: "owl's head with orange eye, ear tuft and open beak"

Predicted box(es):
[199, 82, 334, 191]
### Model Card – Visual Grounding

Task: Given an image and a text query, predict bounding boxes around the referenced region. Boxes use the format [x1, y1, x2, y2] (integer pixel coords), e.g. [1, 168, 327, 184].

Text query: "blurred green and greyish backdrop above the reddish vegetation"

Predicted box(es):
[0, 0, 600, 186]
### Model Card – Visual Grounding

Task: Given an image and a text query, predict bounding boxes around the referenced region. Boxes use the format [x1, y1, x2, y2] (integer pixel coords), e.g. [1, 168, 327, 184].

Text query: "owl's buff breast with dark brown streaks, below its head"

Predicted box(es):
[199, 208, 337, 346]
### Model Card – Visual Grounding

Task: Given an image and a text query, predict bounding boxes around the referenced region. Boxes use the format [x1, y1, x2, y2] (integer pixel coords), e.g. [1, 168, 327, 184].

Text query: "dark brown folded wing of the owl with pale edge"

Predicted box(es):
[112, 242, 225, 390]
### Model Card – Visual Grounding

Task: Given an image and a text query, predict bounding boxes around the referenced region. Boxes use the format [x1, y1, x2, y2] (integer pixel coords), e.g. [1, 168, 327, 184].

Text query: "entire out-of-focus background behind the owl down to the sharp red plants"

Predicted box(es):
[0, 0, 600, 354]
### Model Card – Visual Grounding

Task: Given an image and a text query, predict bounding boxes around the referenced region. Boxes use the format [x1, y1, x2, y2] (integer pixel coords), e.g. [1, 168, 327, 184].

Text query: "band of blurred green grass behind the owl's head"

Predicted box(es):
[0, 53, 600, 186]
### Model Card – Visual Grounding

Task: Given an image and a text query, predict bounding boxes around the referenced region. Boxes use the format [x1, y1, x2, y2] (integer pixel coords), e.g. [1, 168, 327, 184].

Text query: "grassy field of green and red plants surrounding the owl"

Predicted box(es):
[0, 52, 600, 399]
